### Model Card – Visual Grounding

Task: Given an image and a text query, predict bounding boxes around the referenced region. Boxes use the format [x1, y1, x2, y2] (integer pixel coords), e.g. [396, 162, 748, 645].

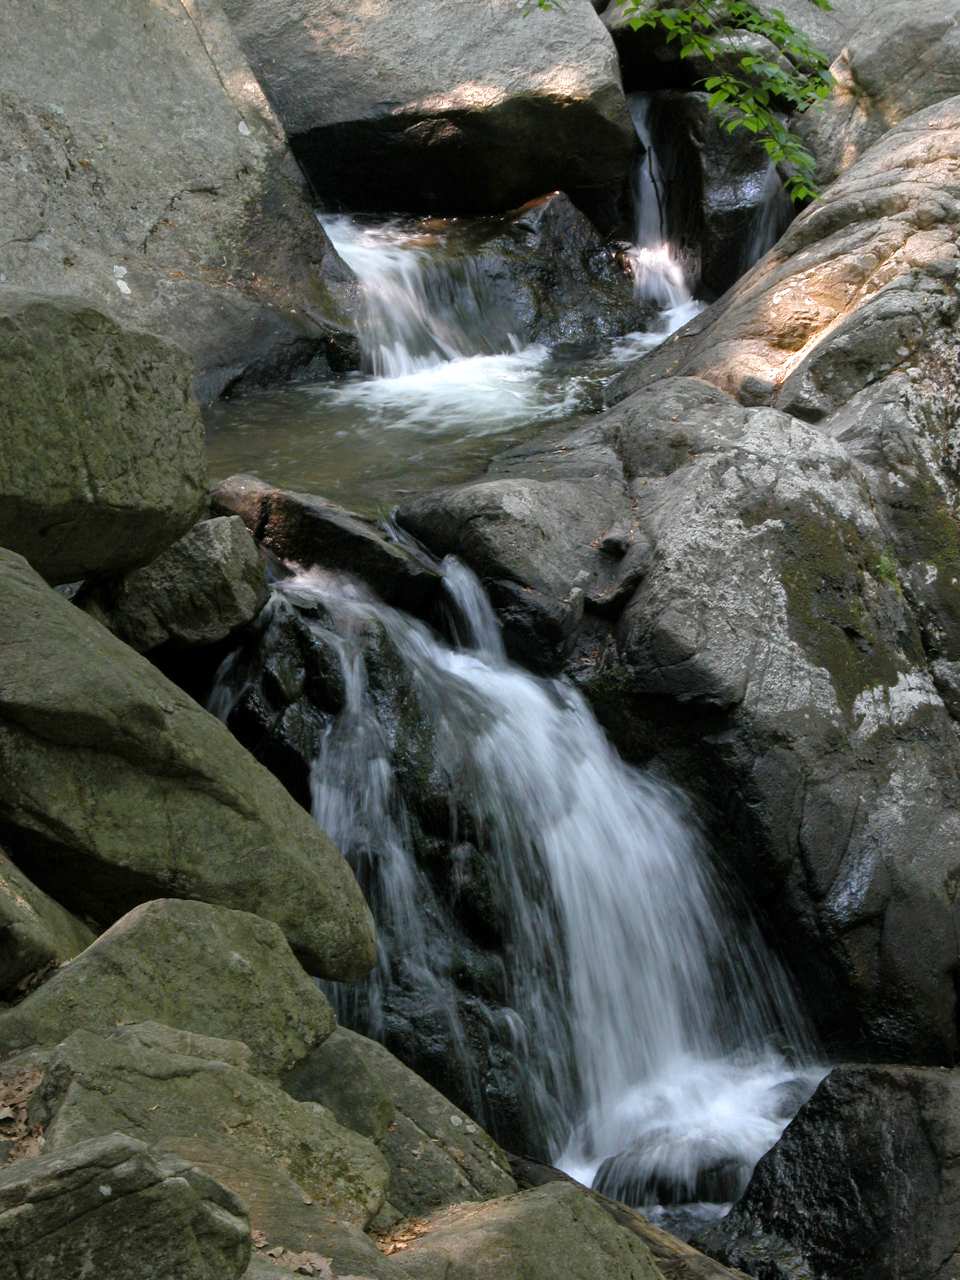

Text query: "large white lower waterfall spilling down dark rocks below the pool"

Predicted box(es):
[210, 559, 819, 1204]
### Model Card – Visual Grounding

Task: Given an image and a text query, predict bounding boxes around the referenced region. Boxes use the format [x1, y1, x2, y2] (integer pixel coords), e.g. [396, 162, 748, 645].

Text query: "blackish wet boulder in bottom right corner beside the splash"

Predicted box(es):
[700, 1066, 960, 1280]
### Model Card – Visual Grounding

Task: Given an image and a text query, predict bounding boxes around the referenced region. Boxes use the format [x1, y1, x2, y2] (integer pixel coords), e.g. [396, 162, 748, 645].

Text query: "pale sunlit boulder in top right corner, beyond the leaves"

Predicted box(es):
[797, 0, 960, 184]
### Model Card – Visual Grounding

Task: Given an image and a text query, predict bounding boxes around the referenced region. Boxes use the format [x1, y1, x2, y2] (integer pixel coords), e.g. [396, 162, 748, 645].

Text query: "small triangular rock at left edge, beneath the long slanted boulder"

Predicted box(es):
[0, 850, 93, 1000]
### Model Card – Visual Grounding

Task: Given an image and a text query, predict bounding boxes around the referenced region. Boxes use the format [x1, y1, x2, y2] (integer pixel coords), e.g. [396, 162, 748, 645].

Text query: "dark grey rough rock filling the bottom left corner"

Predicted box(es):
[0, 1133, 250, 1280]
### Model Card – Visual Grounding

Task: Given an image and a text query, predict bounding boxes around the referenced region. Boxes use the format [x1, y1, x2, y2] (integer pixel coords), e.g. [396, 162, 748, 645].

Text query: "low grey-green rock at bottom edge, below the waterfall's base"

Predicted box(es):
[393, 1183, 658, 1280]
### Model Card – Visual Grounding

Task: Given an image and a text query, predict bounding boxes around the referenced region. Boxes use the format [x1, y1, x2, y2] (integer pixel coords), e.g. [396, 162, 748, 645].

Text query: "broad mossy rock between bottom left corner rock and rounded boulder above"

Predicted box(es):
[29, 1025, 389, 1233]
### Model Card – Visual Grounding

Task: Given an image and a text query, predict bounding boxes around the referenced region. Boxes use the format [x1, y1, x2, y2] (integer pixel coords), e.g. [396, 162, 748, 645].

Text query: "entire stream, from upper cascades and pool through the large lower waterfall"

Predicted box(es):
[210, 104, 822, 1229]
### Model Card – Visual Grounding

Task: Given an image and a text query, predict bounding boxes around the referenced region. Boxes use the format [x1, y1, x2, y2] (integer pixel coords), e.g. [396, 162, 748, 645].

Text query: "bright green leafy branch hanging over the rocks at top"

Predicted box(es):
[536, 0, 833, 201]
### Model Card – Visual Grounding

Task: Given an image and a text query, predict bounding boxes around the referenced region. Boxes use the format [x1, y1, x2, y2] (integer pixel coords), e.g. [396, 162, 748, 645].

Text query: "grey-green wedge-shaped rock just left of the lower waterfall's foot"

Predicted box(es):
[284, 1027, 516, 1217]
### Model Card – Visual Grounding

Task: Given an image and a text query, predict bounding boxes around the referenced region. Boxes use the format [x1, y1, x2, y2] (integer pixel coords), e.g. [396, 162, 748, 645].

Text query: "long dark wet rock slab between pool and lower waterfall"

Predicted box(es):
[211, 476, 440, 613]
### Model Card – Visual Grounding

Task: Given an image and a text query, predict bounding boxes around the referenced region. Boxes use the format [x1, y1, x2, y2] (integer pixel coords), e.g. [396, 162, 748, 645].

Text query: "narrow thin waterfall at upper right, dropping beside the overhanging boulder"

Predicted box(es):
[627, 93, 703, 346]
